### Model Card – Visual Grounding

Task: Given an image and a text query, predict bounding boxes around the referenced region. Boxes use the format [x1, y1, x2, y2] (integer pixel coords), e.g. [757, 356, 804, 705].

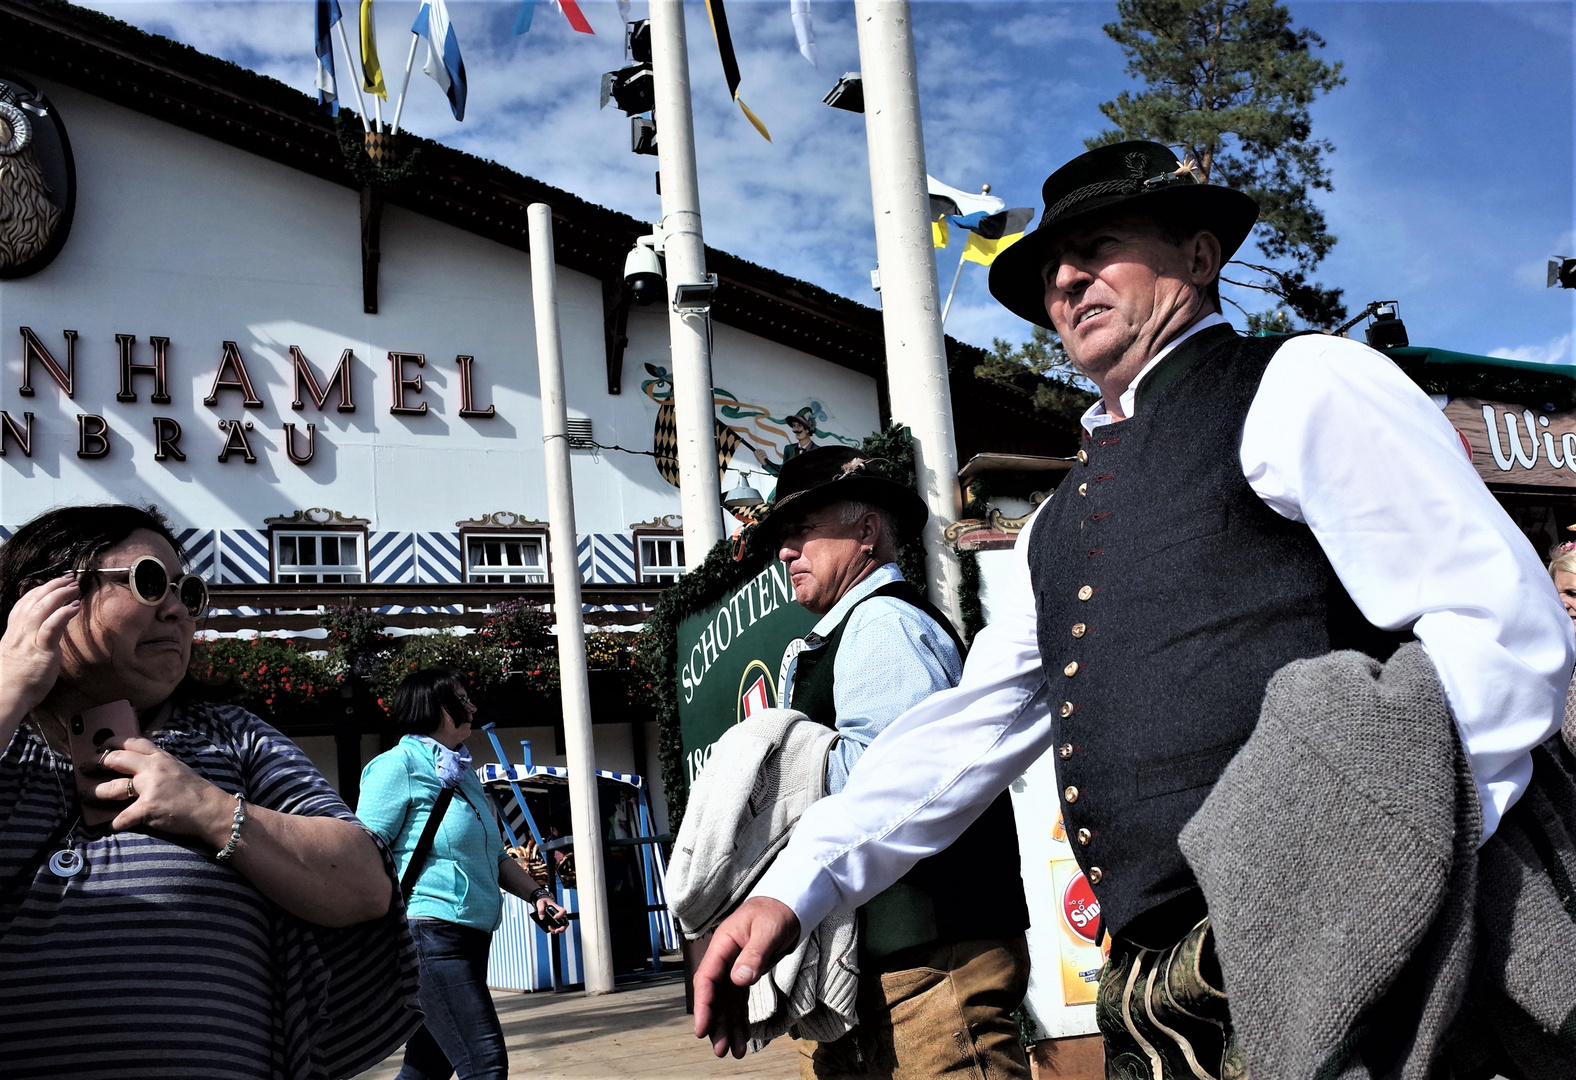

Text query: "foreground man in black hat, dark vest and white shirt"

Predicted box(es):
[695, 142, 1571, 1080]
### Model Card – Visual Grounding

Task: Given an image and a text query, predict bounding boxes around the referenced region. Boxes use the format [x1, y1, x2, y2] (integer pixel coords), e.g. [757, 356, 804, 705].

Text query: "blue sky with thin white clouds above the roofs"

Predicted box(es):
[79, 0, 1576, 363]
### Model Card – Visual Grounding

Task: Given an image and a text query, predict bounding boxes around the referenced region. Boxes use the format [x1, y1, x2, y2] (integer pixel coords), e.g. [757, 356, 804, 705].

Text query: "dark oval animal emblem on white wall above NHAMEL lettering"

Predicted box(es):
[0, 76, 77, 279]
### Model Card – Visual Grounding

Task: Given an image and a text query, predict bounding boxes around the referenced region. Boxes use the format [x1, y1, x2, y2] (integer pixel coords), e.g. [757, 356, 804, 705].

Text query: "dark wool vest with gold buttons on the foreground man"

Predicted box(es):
[1029, 326, 1401, 948]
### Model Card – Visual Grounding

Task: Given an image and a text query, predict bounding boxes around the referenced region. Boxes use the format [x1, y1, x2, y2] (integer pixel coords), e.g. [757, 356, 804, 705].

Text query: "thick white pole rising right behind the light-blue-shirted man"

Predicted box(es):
[854, 0, 963, 626]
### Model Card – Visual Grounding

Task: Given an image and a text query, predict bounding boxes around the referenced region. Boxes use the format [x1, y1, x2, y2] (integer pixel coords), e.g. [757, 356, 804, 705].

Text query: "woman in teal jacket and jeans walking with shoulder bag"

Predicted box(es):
[356, 667, 563, 1080]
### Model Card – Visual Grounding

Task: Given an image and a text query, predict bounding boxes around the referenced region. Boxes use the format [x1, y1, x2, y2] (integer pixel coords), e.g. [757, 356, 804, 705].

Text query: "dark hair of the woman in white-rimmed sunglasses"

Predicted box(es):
[0, 503, 189, 628]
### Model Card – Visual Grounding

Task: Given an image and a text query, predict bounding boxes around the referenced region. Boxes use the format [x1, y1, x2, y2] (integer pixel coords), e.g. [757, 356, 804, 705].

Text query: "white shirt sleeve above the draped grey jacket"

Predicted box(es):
[1242, 336, 1573, 839]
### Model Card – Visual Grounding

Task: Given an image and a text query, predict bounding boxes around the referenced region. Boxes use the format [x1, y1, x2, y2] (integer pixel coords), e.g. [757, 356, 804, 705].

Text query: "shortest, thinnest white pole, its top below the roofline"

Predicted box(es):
[525, 202, 613, 995]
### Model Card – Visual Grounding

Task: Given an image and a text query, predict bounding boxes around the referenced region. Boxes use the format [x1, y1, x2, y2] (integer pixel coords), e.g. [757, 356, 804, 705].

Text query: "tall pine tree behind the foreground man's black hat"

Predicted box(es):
[1087, 0, 1346, 326]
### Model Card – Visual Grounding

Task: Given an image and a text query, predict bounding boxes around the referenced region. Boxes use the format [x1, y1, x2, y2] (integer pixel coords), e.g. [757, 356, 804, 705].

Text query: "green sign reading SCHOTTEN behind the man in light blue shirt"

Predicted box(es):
[678, 558, 816, 784]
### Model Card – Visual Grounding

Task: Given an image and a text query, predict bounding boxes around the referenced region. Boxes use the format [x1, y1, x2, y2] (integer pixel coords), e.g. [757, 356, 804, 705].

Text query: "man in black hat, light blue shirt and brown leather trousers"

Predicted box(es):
[761, 446, 1029, 1080]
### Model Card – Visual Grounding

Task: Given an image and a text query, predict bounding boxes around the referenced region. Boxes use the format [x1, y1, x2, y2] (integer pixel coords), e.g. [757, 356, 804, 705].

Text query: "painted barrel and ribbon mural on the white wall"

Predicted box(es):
[640, 364, 859, 487]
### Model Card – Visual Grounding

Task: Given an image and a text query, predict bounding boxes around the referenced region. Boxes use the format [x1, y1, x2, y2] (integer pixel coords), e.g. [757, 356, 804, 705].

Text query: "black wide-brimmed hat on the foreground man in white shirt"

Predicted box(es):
[990, 142, 1259, 330]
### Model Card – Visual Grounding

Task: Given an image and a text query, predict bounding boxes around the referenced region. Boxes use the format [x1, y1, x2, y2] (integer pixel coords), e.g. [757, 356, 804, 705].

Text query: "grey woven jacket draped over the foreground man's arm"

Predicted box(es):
[1180, 645, 1576, 1080]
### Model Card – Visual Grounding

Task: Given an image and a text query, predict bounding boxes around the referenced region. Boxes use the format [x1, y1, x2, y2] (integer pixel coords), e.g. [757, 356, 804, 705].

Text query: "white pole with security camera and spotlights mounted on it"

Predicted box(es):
[649, 0, 723, 554]
